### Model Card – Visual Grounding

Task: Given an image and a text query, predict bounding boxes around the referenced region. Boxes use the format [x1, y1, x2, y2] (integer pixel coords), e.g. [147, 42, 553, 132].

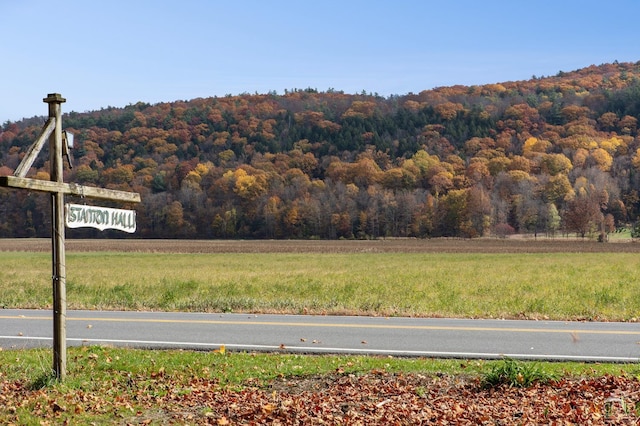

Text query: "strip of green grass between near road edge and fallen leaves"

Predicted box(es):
[0, 346, 640, 389]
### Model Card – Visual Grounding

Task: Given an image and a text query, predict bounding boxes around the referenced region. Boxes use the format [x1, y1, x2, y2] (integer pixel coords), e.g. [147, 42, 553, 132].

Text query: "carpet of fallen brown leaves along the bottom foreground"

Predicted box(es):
[0, 369, 640, 425]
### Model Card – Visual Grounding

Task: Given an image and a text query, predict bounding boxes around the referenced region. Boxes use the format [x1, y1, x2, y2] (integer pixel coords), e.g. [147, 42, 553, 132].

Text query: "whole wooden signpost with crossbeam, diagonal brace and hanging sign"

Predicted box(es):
[0, 93, 140, 380]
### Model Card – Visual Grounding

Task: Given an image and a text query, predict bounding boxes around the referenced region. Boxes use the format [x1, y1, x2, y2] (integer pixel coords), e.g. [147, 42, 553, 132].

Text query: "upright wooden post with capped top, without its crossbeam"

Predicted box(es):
[44, 93, 67, 380]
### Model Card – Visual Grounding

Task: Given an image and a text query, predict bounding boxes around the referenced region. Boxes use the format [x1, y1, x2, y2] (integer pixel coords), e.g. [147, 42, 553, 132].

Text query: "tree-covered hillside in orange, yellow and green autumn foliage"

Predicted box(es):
[0, 62, 640, 238]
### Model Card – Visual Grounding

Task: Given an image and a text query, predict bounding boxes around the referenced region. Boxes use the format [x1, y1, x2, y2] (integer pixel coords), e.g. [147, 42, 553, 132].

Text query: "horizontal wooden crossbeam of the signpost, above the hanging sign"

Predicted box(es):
[0, 176, 141, 203]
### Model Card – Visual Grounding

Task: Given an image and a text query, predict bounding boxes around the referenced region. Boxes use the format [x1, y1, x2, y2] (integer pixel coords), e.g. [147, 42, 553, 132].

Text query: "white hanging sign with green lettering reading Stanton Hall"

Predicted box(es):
[64, 203, 136, 233]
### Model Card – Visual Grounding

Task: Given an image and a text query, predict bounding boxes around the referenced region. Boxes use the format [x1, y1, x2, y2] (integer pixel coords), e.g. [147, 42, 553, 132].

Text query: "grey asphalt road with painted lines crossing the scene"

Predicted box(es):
[0, 309, 640, 362]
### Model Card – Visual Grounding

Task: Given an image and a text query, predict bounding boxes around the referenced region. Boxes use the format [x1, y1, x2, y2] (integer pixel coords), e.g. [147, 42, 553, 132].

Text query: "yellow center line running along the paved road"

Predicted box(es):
[0, 315, 640, 335]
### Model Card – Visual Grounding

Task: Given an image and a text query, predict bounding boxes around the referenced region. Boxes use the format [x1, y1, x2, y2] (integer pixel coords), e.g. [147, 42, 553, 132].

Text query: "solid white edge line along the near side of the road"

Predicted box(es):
[0, 336, 640, 363]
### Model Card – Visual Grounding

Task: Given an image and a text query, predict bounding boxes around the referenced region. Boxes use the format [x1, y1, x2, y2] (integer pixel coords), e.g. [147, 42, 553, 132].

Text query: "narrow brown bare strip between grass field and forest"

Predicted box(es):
[0, 237, 640, 253]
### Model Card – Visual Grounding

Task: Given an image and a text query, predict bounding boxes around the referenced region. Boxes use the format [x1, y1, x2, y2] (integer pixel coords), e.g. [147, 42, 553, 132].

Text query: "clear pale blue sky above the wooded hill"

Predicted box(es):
[0, 0, 640, 124]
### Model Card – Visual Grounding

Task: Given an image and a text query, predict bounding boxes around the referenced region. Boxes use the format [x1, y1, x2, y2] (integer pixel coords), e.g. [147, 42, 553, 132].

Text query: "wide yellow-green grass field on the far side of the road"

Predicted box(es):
[0, 252, 640, 320]
